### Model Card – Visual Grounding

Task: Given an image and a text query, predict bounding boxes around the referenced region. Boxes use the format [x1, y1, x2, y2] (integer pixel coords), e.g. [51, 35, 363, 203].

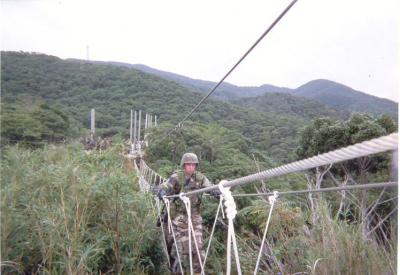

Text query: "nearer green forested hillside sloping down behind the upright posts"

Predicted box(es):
[1, 52, 318, 161]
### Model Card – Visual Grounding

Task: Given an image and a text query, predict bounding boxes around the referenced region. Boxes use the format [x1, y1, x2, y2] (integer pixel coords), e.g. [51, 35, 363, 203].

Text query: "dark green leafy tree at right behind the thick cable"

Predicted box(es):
[296, 114, 397, 240]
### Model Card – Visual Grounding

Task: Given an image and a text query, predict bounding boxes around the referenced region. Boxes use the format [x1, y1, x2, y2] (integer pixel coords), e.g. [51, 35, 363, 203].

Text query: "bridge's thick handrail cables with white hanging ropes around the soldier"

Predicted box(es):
[134, 133, 398, 274]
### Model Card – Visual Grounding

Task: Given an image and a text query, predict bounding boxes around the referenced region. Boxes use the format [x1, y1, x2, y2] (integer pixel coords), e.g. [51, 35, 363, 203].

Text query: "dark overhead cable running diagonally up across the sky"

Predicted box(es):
[161, 0, 297, 140]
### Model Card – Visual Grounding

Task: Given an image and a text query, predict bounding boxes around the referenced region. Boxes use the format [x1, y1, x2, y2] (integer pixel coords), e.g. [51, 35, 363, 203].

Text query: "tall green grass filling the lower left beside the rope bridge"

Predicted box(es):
[1, 144, 164, 274]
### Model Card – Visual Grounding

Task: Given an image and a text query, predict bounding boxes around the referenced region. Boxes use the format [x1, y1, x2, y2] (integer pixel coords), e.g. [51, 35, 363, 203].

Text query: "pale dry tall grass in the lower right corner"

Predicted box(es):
[307, 202, 397, 275]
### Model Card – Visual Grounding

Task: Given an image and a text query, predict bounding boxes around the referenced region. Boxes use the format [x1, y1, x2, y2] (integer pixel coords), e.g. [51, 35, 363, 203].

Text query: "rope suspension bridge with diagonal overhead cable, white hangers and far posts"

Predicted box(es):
[81, 0, 398, 274]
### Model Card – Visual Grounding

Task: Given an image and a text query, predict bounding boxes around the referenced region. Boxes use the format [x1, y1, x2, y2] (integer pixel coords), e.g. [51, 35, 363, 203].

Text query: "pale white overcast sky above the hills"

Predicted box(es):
[1, 0, 399, 101]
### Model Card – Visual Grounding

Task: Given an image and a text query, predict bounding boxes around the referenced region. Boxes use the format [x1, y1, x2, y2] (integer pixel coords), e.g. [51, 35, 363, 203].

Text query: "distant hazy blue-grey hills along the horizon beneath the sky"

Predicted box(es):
[106, 62, 398, 118]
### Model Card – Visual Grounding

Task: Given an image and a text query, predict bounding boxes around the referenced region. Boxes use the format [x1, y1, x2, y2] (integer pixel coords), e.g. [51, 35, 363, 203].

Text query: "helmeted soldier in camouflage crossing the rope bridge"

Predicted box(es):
[158, 153, 221, 274]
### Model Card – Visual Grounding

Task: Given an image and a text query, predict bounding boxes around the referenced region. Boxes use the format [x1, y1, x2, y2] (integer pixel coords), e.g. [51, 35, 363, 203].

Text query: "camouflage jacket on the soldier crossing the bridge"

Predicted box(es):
[160, 170, 212, 216]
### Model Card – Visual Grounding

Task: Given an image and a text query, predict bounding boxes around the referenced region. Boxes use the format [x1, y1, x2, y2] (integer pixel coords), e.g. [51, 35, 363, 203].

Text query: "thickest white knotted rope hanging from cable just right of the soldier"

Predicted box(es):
[218, 180, 242, 275]
